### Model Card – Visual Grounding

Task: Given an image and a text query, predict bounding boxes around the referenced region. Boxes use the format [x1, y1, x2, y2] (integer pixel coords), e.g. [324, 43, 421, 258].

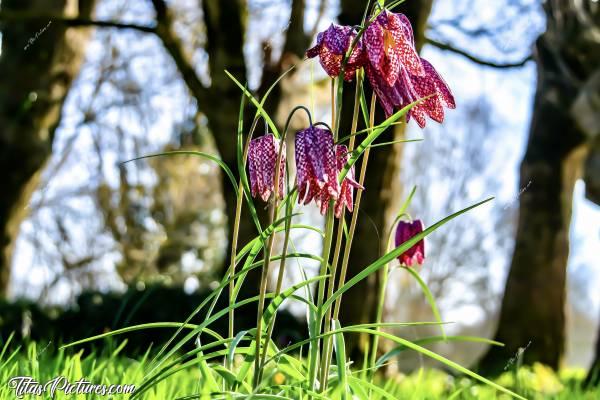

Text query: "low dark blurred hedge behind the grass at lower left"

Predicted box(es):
[0, 285, 308, 354]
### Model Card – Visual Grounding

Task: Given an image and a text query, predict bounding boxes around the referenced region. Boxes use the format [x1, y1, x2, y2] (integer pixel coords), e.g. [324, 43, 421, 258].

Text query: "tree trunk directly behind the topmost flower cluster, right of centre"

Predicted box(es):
[339, 0, 433, 360]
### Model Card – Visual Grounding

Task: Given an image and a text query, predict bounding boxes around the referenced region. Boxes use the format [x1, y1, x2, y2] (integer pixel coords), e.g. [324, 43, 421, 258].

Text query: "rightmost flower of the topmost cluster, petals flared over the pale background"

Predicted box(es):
[396, 58, 456, 128]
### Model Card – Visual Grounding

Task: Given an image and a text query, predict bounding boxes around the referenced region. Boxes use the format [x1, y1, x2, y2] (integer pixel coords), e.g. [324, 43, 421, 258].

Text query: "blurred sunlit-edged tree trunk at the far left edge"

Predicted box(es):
[0, 0, 94, 297]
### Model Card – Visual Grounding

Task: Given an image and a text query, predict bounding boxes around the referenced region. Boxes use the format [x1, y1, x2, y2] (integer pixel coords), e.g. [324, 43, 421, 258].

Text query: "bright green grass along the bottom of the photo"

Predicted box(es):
[0, 342, 600, 400]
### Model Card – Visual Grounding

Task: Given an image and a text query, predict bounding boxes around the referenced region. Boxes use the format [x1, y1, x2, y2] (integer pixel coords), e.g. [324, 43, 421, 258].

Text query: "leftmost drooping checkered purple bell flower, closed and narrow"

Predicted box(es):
[248, 134, 286, 201]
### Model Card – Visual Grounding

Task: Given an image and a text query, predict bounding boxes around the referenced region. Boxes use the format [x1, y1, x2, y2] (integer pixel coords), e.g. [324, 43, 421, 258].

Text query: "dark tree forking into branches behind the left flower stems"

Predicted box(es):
[152, 0, 309, 296]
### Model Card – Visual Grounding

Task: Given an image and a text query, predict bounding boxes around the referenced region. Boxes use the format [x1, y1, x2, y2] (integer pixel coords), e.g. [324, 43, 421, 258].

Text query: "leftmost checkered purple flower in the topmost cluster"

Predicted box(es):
[306, 24, 364, 81]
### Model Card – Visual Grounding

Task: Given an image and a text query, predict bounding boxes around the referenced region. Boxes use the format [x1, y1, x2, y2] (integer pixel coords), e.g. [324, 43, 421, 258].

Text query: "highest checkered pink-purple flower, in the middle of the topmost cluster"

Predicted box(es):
[363, 10, 425, 86]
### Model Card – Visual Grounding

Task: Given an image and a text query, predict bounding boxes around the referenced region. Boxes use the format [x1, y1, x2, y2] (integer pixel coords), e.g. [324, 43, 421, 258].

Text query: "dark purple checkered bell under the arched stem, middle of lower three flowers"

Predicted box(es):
[295, 126, 340, 204]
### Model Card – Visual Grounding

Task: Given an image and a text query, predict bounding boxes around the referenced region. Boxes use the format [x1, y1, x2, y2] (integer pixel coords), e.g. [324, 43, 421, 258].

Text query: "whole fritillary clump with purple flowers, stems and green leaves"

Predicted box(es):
[68, 1, 519, 399]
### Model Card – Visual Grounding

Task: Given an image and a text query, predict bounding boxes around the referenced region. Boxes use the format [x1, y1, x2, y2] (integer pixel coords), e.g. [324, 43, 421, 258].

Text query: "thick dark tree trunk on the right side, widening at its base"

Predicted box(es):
[480, 0, 600, 373]
